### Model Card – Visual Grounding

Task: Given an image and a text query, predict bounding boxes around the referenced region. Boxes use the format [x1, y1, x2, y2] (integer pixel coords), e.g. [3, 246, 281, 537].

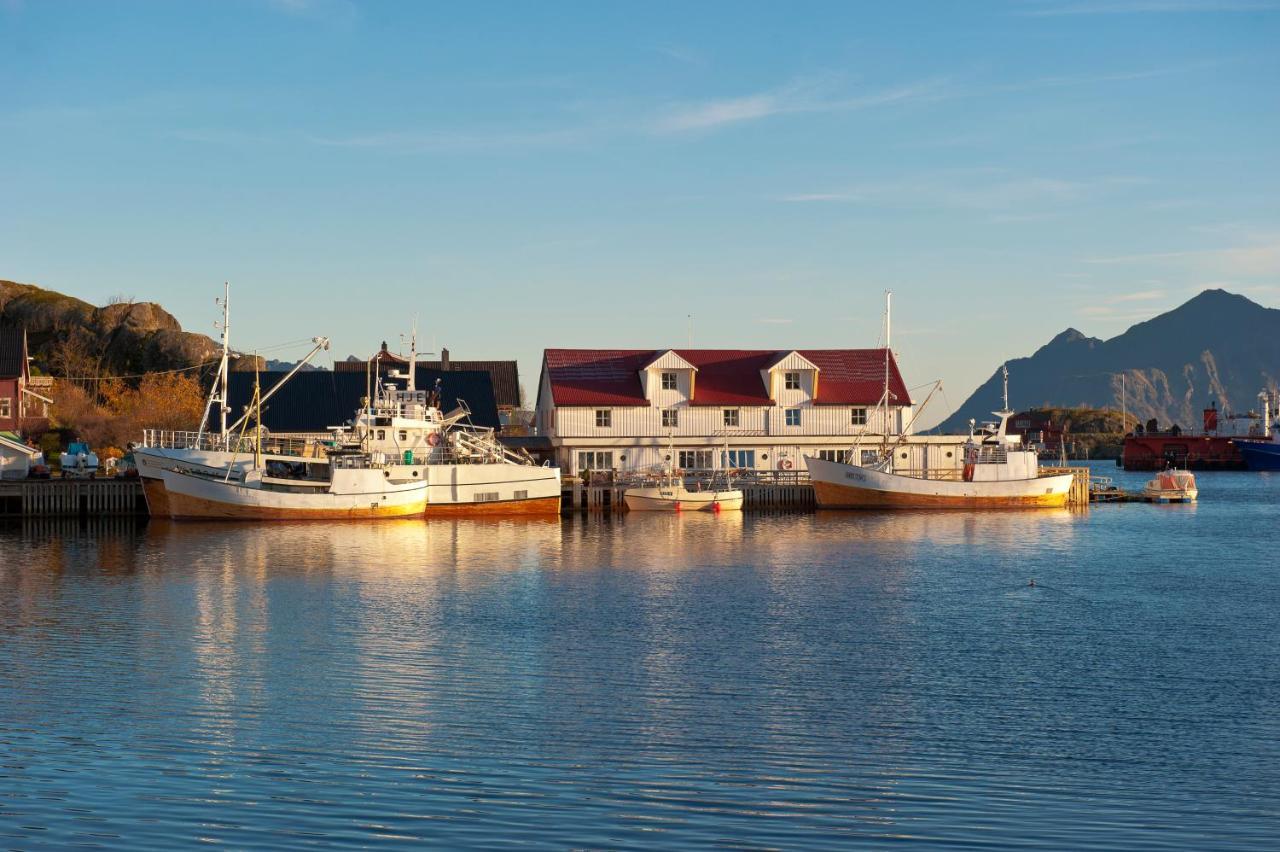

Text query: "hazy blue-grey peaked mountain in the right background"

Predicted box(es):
[940, 290, 1280, 432]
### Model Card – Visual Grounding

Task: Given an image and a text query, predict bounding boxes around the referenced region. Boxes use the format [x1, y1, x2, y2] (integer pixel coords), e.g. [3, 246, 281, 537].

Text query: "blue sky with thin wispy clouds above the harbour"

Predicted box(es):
[0, 0, 1280, 425]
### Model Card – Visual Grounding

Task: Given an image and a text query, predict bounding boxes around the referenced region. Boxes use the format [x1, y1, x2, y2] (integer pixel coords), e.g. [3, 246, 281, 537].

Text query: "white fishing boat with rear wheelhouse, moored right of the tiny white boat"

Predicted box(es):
[805, 355, 1074, 509]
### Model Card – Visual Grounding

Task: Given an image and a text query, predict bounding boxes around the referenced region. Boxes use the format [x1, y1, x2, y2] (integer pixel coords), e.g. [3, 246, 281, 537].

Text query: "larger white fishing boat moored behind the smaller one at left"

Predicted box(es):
[133, 284, 561, 516]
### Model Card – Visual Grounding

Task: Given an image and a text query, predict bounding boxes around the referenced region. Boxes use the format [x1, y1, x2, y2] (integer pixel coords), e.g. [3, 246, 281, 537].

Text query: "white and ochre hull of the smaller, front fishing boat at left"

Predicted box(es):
[164, 471, 426, 521]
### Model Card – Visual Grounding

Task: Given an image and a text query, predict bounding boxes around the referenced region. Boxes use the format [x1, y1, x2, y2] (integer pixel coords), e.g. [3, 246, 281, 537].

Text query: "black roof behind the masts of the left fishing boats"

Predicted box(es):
[228, 366, 499, 432]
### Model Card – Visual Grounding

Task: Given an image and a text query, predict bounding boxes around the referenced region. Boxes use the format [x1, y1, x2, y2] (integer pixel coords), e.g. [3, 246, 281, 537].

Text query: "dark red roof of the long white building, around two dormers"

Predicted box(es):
[544, 349, 911, 406]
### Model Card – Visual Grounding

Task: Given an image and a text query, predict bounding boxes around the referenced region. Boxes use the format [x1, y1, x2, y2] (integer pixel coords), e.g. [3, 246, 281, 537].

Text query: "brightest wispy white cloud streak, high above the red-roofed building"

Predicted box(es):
[653, 79, 946, 133]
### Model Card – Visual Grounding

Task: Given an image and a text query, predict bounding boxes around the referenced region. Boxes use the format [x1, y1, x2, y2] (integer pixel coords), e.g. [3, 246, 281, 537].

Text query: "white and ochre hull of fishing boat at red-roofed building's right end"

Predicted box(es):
[805, 458, 1073, 509]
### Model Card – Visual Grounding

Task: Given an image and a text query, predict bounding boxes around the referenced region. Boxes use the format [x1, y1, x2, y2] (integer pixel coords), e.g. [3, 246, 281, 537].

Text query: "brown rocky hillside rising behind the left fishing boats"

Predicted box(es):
[0, 280, 226, 376]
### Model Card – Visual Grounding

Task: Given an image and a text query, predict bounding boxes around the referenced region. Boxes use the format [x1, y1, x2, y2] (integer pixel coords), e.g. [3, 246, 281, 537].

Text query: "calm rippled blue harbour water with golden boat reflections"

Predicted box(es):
[0, 460, 1280, 849]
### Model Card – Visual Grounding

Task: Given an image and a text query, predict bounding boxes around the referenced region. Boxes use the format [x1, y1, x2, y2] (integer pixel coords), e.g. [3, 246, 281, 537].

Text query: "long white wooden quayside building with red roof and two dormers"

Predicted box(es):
[535, 349, 913, 473]
